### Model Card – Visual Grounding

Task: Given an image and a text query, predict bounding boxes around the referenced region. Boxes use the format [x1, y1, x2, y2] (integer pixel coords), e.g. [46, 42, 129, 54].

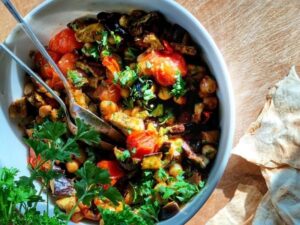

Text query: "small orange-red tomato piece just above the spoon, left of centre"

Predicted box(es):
[95, 83, 121, 102]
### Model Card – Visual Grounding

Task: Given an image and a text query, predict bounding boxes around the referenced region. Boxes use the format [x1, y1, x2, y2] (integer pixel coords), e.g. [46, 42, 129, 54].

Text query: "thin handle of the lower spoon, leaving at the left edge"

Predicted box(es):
[0, 43, 67, 111]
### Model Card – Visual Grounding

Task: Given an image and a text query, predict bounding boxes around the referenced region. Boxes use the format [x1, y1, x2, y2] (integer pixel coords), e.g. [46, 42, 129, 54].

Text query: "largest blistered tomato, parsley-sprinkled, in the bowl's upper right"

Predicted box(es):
[137, 42, 187, 86]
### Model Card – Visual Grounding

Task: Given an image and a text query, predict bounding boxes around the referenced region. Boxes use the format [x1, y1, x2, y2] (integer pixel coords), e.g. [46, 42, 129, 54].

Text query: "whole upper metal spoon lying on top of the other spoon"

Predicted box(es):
[2, 0, 124, 142]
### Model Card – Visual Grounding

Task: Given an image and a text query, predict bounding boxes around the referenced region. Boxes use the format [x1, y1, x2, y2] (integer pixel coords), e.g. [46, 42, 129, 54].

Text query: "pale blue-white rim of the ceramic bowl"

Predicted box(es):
[4, 0, 235, 225]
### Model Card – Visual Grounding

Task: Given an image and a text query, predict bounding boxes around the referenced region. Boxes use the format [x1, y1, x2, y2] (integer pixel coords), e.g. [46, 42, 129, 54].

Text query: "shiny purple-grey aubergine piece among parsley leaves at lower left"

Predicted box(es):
[50, 176, 75, 197]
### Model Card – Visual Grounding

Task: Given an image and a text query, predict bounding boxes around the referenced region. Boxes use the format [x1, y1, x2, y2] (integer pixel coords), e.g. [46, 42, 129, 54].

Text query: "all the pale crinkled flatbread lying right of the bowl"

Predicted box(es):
[207, 67, 300, 225]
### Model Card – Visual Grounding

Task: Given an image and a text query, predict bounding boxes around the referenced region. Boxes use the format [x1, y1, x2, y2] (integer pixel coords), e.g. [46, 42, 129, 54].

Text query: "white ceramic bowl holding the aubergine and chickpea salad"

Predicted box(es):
[0, 0, 234, 225]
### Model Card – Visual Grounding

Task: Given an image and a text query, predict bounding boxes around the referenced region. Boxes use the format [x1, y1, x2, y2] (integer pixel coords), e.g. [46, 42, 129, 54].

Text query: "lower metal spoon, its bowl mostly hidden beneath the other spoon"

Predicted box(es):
[0, 43, 114, 150]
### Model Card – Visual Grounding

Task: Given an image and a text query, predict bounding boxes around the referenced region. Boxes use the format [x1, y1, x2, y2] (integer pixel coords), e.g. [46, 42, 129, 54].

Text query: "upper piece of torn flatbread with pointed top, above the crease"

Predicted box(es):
[233, 67, 300, 169]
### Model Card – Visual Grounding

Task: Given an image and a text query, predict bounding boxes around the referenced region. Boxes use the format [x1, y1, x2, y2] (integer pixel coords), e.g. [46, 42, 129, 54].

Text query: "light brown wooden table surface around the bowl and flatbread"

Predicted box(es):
[0, 0, 300, 225]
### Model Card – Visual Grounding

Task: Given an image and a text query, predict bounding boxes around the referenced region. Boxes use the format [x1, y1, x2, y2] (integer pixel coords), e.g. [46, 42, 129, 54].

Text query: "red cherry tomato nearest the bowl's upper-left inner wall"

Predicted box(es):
[49, 28, 82, 54]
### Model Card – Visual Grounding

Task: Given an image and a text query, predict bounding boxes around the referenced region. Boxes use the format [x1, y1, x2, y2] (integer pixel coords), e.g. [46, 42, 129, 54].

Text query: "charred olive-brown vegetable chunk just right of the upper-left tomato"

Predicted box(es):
[75, 23, 104, 43]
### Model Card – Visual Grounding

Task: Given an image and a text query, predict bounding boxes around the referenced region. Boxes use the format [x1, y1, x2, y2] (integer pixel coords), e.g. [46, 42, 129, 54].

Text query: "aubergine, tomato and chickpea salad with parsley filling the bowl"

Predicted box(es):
[9, 10, 220, 225]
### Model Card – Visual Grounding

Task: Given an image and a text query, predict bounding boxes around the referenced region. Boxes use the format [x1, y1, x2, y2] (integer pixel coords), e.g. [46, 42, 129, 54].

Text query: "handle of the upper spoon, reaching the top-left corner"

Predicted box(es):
[1, 0, 73, 99]
